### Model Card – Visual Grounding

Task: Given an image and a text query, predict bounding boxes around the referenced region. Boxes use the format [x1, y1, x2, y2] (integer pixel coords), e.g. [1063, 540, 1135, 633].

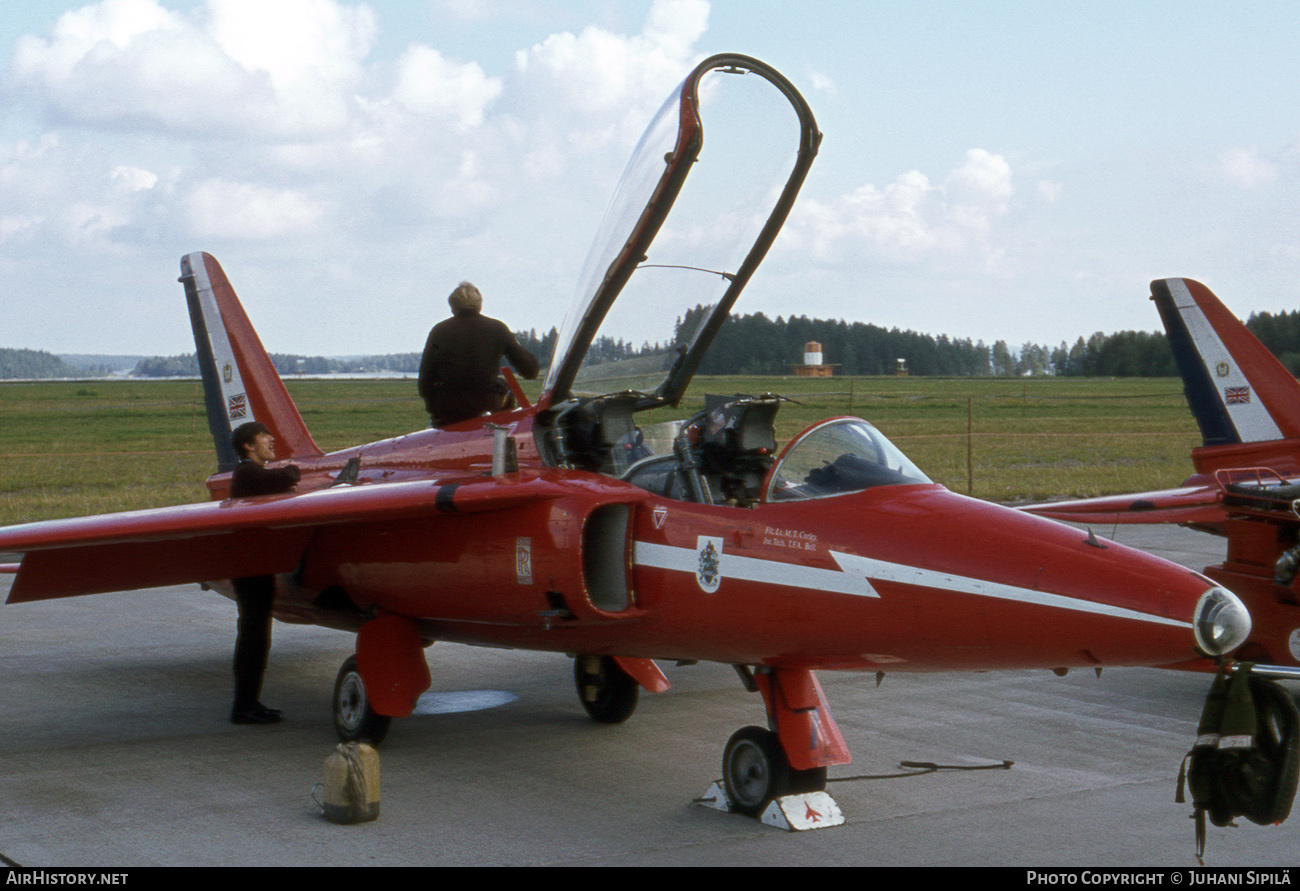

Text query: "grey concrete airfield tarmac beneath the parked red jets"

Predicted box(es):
[0, 527, 1300, 868]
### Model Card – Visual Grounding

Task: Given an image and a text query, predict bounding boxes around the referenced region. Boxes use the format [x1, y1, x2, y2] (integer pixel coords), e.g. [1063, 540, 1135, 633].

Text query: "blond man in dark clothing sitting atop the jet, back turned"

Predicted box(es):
[420, 281, 540, 427]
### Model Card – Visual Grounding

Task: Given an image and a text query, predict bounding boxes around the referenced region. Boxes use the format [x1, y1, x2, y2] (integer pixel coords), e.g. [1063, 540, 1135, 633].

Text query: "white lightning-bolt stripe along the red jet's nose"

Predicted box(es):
[634, 541, 1192, 628]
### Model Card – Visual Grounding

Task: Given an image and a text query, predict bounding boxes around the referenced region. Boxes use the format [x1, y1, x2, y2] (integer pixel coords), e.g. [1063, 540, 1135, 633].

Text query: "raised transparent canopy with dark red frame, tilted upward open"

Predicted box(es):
[541, 55, 820, 408]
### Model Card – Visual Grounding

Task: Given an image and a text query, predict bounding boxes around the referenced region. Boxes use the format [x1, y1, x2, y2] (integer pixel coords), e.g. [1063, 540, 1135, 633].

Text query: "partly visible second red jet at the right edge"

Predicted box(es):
[1024, 278, 1300, 667]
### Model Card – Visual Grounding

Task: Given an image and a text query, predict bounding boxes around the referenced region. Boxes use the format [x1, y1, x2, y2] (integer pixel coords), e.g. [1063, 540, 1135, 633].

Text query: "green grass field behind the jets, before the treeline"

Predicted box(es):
[0, 377, 1200, 524]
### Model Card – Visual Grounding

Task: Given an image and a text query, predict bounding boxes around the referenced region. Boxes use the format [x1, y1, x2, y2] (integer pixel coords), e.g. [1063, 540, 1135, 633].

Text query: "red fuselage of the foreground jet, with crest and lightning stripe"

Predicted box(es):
[236, 400, 1227, 671]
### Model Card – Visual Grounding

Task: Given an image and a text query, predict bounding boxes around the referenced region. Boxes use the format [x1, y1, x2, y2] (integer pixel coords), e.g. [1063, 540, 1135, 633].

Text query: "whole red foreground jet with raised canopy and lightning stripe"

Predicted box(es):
[0, 56, 1251, 814]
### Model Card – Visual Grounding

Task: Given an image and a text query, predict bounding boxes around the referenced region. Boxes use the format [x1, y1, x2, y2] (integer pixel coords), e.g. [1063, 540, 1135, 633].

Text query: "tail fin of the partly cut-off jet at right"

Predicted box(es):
[1151, 278, 1300, 446]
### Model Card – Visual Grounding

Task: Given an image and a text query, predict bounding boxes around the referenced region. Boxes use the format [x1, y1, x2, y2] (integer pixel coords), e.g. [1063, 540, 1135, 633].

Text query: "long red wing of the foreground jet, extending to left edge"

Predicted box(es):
[0, 473, 569, 604]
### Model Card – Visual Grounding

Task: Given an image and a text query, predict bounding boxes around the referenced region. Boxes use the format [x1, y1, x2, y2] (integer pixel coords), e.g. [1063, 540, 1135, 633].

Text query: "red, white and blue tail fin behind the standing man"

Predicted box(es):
[181, 252, 322, 471]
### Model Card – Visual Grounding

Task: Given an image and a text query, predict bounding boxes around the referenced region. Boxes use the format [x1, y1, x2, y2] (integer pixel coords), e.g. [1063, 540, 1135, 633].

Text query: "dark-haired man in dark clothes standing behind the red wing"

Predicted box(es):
[230, 421, 302, 725]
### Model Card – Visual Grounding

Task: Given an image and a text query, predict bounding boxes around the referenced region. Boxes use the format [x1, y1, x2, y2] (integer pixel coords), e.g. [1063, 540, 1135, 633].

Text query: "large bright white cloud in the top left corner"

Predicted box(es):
[10, 0, 377, 139]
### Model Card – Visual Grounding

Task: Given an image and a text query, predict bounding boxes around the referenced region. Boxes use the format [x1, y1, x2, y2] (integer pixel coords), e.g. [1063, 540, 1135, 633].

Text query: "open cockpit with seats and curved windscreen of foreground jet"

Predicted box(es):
[540, 392, 931, 507]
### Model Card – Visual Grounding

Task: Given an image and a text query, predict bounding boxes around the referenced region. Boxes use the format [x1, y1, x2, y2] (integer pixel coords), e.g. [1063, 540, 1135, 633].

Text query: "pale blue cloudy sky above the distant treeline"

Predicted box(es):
[0, 0, 1300, 355]
